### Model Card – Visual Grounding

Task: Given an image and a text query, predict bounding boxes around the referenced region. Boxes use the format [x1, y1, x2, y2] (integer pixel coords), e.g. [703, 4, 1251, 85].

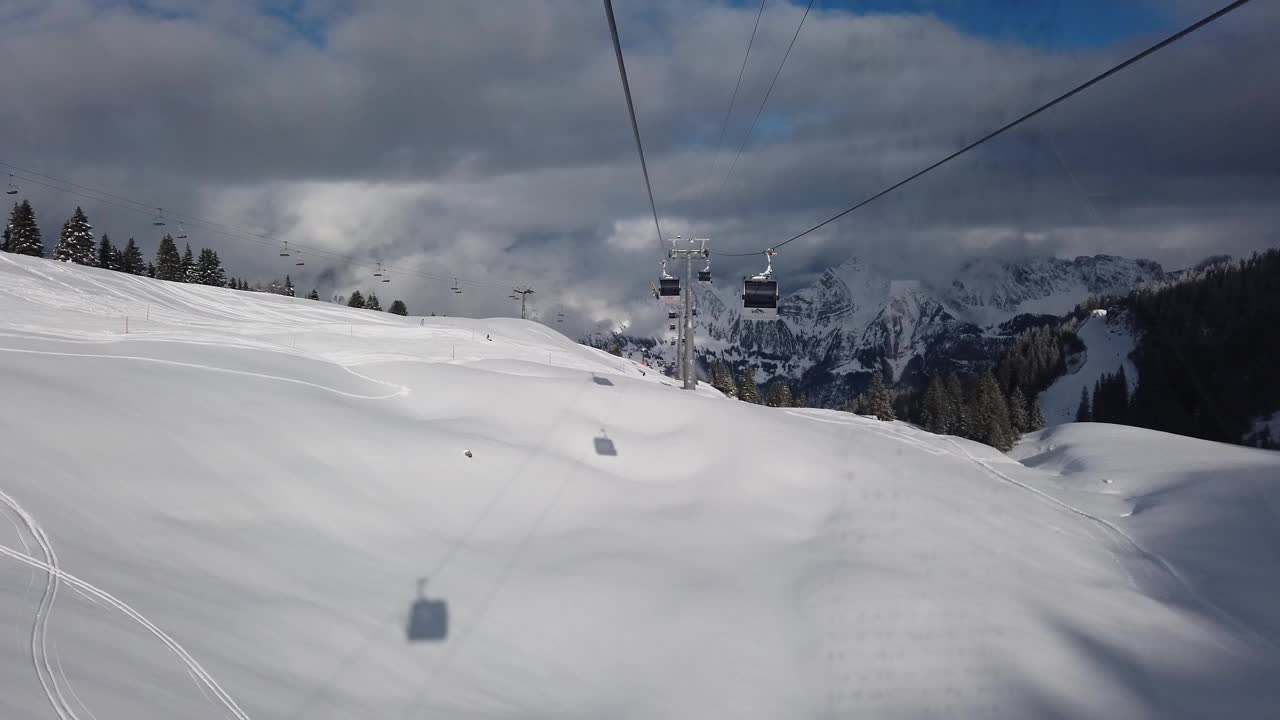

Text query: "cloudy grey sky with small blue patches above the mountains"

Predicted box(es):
[0, 0, 1280, 334]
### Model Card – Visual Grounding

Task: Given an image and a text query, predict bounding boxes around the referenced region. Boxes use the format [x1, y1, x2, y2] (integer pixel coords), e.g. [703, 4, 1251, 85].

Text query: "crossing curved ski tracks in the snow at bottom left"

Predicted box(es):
[0, 491, 251, 720]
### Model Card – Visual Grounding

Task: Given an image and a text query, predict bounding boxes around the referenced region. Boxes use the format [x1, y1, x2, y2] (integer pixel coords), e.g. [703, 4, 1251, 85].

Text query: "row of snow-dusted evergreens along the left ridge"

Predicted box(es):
[0, 200, 408, 315]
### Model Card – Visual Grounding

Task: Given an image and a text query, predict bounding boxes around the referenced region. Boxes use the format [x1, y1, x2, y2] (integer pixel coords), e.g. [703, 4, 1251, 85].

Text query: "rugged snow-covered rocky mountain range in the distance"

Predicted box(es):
[606, 255, 1169, 405]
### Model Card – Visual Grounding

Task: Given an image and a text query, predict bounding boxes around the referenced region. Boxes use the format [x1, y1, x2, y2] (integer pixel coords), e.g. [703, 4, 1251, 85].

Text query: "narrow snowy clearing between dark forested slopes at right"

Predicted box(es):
[1041, 310, 1138, 425]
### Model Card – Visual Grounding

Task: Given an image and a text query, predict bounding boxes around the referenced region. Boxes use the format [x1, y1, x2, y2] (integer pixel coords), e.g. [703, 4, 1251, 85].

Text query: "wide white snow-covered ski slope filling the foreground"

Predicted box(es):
[0, 254, 1280, 720]
